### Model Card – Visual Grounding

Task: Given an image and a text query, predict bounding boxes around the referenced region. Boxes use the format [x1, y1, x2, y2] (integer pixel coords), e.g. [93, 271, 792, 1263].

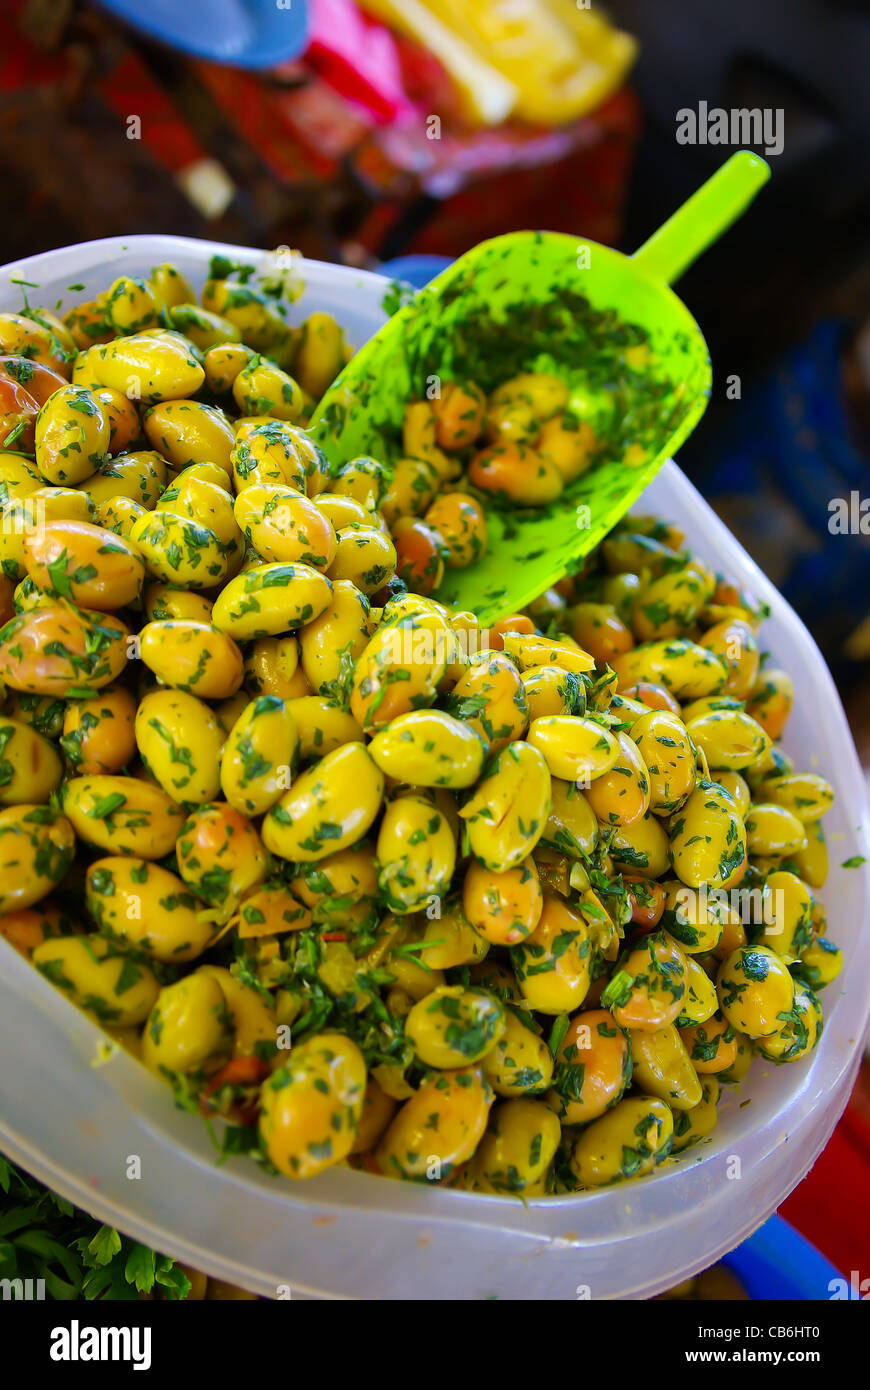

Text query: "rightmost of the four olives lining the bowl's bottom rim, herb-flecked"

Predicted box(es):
[568, 1097, 674, 1187]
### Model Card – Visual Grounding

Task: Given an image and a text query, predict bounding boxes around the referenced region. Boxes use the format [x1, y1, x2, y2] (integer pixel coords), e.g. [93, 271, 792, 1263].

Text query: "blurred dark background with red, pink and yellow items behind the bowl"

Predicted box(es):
[0, 0, 870, 1301]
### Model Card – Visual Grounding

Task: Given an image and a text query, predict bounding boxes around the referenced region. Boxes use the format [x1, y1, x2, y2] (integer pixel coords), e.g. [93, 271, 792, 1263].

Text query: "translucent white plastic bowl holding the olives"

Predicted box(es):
[0, 236, 870, 1300]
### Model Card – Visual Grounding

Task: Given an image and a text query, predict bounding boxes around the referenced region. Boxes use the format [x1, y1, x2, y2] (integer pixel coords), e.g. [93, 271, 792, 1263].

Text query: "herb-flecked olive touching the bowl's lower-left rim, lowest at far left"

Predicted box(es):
[32, 935, 160, 1027]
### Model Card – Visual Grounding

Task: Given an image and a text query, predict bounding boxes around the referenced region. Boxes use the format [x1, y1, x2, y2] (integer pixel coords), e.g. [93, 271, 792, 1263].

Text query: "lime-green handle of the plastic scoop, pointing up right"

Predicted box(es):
[631, 150, 770, 285]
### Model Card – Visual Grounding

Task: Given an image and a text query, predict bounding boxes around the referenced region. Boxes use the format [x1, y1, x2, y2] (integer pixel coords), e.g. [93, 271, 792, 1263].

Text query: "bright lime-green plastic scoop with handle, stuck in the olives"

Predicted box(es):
[313, 150, 770, 624]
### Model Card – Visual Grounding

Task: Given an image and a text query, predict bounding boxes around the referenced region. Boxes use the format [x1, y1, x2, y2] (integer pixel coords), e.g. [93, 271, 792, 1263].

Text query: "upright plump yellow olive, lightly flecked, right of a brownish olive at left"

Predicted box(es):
[135, 689, 224, 808]
